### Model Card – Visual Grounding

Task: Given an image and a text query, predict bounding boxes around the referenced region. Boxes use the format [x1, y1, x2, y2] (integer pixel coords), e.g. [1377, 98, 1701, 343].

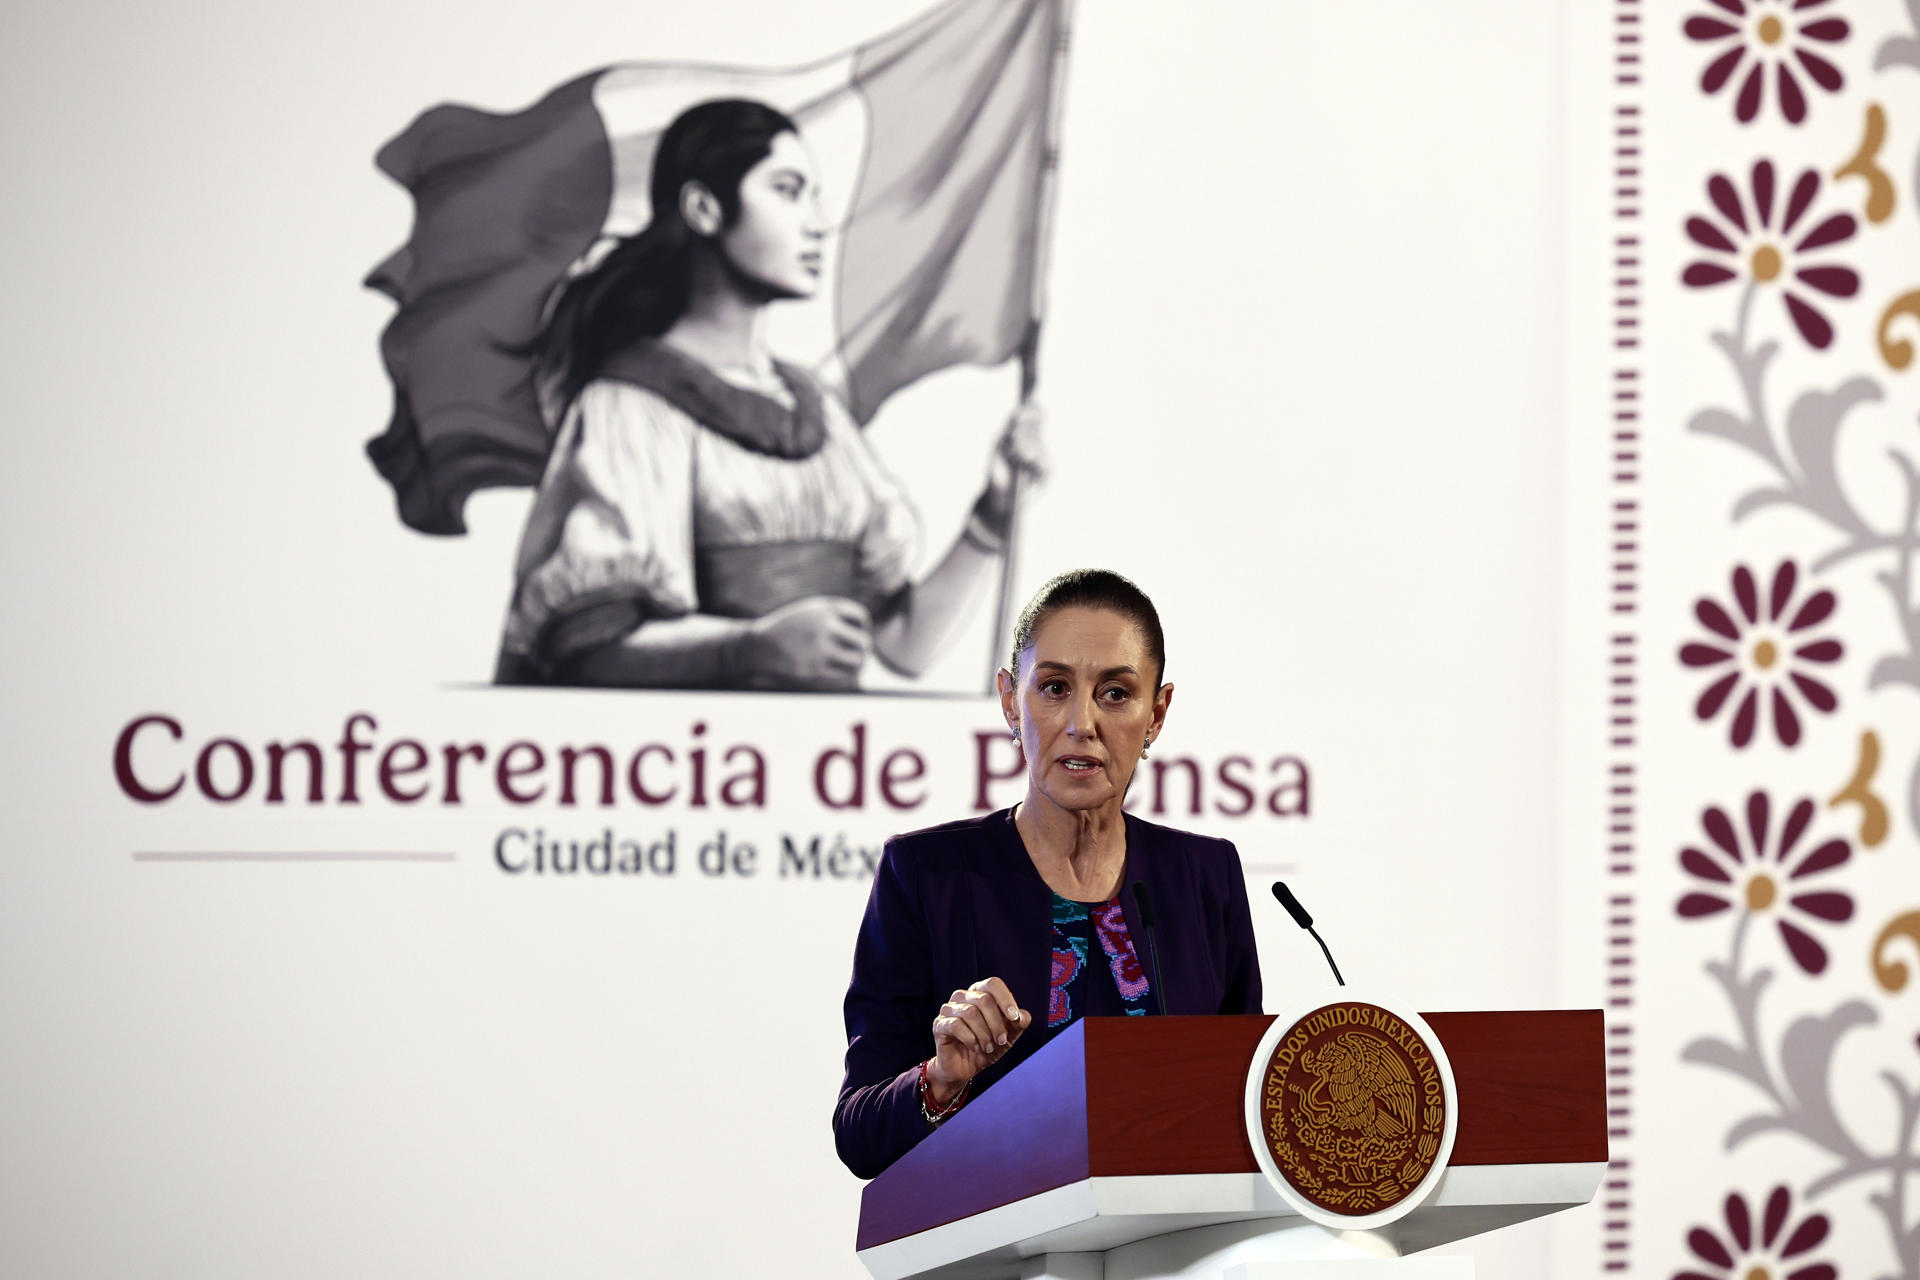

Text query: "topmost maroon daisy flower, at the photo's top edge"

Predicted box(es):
[1684, 0, 1849, 125]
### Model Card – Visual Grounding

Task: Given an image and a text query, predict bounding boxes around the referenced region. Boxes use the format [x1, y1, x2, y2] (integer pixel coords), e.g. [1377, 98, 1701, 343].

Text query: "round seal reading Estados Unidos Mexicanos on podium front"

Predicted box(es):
[1248, 1000, 1453, 1226]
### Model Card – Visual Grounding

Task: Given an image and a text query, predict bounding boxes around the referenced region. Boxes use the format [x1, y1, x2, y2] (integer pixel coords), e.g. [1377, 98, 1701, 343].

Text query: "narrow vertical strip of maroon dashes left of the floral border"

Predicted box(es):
[1601, 0, 1645, 1272]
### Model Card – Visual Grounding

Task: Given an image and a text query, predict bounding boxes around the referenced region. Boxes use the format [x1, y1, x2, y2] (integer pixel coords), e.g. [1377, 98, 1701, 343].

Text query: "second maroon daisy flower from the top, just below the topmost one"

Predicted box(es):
[1680, 159, 1860, 351]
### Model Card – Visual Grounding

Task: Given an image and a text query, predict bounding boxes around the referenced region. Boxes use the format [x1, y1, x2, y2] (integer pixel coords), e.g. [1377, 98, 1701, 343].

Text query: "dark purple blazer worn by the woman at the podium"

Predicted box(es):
[833, 810, 1261, 1178]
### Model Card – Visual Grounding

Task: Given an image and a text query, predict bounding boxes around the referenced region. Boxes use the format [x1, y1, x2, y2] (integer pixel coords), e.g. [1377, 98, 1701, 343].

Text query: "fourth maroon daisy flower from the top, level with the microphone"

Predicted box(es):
[1676, 791, 1853, 973]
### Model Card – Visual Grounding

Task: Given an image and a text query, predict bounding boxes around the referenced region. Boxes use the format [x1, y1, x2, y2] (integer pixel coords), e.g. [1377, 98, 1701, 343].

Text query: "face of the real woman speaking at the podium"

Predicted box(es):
[1000, 608, 1173, 810]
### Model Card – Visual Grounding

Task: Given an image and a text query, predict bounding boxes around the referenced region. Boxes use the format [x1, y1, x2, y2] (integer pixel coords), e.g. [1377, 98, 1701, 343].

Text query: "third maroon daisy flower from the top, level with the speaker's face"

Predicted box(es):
[1680, 560, 1843, 747]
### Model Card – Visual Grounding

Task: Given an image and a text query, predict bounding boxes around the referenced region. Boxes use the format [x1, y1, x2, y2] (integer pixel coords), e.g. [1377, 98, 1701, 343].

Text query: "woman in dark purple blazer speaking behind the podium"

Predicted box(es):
[833, 570, 1261, 1178]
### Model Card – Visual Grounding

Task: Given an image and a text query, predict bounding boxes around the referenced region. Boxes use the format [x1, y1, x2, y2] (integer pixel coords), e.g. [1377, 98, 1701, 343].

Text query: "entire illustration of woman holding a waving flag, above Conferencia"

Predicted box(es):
[369, 0, 1064, 691]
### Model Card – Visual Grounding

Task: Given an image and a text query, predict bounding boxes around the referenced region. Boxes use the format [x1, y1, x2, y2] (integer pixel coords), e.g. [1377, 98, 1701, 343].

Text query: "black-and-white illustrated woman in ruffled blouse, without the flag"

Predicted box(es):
[495, 100, 1041, 689]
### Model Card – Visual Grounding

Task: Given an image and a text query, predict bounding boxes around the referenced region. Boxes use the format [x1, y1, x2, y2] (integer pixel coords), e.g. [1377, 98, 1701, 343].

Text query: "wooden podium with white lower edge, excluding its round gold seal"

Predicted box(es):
[856, 1009, 1607, 1280]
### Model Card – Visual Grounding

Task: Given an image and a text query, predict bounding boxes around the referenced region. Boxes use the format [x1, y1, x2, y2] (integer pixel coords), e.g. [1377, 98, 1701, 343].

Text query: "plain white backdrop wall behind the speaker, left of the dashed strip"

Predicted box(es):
[0, 0, 1601, 1276]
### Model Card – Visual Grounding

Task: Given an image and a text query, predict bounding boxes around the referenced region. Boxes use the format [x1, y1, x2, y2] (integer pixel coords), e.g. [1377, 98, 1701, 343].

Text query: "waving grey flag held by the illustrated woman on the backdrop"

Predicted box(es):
[367, 0, 1066, 533]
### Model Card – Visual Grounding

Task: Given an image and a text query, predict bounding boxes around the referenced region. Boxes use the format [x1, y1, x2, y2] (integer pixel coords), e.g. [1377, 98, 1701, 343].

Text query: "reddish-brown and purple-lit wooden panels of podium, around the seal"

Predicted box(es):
[856, 1009, 1607, 1257]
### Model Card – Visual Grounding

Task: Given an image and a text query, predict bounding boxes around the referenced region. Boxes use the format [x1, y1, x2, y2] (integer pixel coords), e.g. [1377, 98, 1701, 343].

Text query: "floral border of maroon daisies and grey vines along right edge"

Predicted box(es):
[1651, 0, 1920, 1280]
